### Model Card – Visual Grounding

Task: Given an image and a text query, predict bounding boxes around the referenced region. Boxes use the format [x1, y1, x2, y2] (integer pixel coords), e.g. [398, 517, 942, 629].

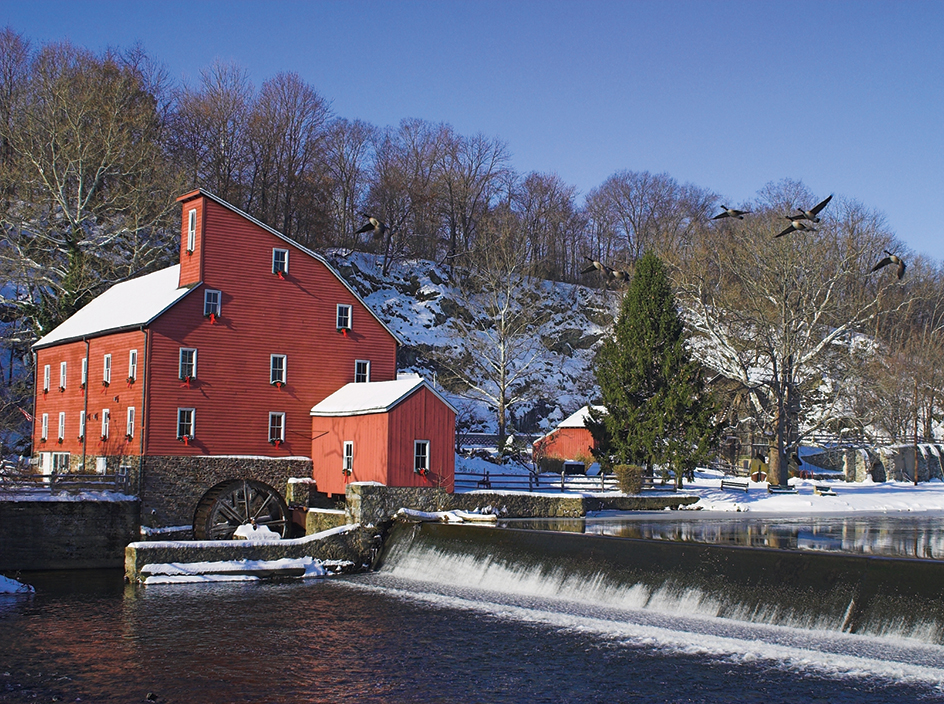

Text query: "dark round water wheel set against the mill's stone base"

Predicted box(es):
[193, 479, 292, 540]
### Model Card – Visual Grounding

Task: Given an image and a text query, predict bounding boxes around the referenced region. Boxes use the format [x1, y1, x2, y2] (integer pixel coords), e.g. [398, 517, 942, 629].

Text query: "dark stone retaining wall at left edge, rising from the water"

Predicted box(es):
[0, 498, 140, 571]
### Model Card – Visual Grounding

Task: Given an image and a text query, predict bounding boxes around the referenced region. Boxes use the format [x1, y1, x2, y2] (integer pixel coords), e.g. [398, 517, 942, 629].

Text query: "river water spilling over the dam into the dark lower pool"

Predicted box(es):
[0, 521, 944, 704]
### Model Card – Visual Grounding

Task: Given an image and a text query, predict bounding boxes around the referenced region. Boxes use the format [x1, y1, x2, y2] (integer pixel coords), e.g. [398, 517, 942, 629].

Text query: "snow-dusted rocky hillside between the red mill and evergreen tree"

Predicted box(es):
[328, 251, 621, 433]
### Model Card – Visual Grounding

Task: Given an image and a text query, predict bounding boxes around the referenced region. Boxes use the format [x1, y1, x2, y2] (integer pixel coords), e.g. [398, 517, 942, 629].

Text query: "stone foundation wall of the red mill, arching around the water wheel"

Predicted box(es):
[139, 457, 311, 528]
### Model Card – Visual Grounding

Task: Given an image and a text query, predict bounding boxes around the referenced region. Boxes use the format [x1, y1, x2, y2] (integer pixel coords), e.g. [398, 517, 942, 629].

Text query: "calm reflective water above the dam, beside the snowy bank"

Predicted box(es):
[503, 513, 944, 560]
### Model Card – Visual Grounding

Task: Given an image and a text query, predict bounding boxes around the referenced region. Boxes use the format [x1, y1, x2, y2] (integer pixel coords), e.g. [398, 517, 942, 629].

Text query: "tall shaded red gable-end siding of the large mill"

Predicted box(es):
[146, 196, 396, 456]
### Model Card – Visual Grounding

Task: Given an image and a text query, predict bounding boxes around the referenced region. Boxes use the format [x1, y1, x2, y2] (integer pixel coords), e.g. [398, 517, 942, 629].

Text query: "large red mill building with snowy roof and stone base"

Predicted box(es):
[33, 190, 455, 526]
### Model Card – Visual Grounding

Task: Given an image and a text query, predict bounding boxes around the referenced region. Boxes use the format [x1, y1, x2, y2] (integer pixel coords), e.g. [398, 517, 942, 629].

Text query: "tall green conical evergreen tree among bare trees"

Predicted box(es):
[587, 252, 719, 486]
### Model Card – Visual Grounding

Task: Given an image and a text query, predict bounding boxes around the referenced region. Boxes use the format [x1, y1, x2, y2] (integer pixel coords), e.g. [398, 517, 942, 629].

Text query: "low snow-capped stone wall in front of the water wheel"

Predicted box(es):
[125, 525, 380, 582]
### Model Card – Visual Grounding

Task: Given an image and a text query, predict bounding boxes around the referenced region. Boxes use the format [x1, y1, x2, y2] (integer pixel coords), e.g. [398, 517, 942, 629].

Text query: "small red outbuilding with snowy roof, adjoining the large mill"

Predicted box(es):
[311, 375, 456, 495]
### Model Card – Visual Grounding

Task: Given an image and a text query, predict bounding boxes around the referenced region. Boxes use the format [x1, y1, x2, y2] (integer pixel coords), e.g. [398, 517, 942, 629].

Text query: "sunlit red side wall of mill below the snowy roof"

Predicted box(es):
[33, 330, 146, 462]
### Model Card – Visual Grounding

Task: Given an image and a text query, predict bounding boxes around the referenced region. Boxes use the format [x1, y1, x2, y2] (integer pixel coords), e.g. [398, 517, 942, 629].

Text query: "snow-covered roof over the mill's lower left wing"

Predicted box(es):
[33, 265, 193, 349]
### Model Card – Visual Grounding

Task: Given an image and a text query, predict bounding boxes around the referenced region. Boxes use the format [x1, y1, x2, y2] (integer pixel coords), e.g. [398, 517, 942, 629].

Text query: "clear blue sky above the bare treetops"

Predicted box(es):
[0, 0, 944, 262]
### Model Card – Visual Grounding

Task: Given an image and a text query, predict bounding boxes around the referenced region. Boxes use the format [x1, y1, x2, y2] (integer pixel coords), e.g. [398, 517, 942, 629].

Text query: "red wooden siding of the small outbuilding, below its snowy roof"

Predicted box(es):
[311, 387, 455, 494]
